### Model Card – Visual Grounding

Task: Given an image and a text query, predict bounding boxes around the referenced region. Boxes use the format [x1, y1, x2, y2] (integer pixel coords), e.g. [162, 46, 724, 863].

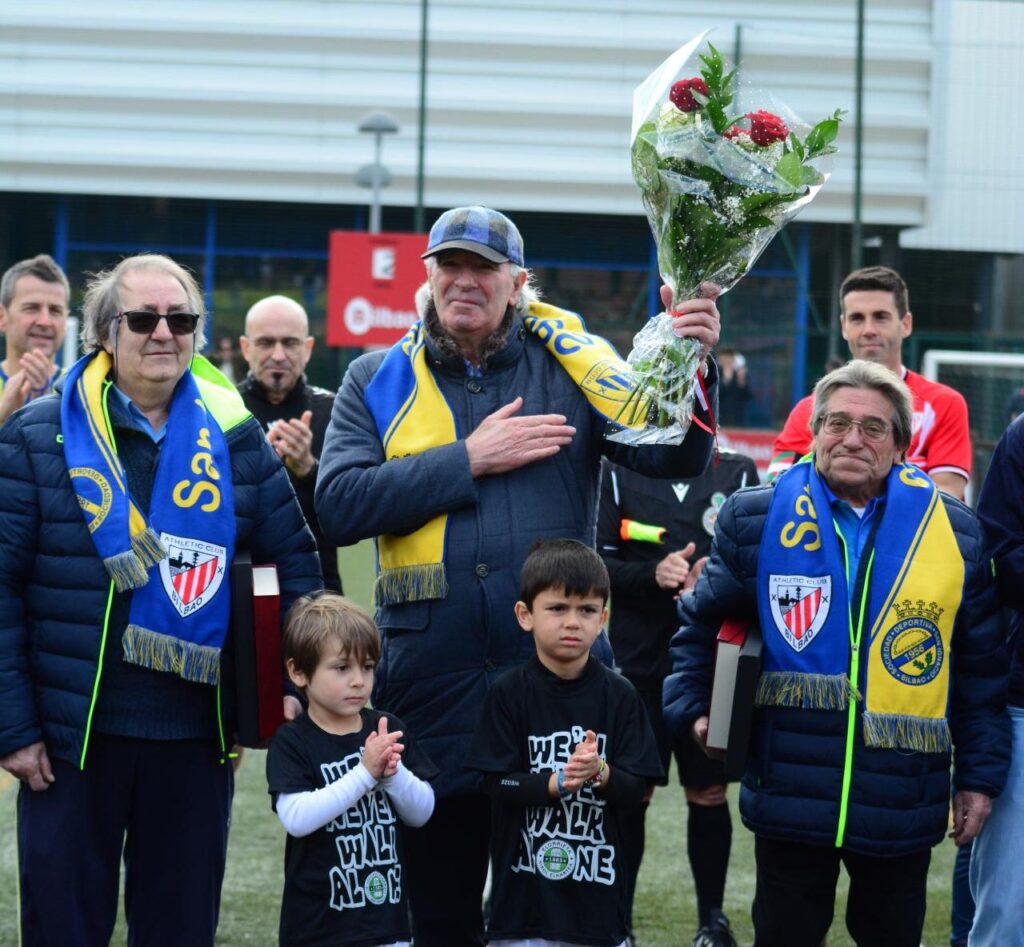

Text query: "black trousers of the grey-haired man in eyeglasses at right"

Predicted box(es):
[753, 835, 932, 947]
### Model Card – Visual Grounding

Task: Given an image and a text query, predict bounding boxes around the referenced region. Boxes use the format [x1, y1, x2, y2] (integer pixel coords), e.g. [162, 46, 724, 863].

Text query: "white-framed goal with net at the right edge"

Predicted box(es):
[921, 349, 1024, 501]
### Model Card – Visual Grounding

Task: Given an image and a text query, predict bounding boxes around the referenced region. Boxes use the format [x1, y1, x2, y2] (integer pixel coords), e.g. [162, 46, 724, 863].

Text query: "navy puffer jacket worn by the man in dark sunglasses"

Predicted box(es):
[0, 386, 322, 765]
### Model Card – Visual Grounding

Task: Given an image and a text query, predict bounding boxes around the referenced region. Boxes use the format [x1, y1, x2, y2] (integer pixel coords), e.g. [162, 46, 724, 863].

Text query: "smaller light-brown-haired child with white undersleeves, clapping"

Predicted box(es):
[266, 592, 437, 947]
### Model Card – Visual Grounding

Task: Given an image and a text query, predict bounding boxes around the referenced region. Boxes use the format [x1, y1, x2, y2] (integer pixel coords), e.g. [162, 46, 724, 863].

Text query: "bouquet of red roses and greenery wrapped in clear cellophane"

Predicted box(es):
[610, 34, 842, 444]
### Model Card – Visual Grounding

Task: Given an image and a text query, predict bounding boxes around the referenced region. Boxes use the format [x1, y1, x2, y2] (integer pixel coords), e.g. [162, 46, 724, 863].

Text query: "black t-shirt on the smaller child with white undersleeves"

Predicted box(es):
[266, 709, 437, 947]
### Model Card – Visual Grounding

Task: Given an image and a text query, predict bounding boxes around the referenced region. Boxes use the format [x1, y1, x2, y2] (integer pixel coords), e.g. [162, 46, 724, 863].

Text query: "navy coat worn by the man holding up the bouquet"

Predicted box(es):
[316, 317, 717, 797]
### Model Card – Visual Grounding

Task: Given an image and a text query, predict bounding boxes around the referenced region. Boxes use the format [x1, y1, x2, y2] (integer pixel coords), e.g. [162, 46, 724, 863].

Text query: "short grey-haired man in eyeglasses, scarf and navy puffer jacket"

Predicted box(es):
[665, 360, 1010, 947]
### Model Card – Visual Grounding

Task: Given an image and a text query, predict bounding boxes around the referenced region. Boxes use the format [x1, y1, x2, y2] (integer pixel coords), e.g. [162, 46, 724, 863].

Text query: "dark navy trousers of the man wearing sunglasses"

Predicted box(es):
[17, 735, 233, 947]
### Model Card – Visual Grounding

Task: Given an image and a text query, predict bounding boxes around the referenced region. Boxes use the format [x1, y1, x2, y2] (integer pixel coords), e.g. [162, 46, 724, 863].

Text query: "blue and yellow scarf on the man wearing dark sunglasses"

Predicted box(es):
[60, 352, 239, 684]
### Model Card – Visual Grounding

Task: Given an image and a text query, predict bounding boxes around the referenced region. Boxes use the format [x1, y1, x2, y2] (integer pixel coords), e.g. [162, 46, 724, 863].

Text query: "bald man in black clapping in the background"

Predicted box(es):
[239, 296, 341, 592]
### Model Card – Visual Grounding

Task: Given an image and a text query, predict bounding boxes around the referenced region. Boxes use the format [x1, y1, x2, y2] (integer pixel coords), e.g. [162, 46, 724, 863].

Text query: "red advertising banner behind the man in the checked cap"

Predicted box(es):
[327, 230, 427, 348]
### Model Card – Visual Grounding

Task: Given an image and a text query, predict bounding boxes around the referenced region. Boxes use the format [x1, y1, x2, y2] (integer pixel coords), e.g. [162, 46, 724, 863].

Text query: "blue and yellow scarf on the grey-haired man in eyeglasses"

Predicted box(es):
[758, 459, 965, 752]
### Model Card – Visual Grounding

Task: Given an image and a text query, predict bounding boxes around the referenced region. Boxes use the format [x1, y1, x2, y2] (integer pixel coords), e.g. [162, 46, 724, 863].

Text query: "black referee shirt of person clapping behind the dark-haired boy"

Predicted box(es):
[597, 450, 759, 682]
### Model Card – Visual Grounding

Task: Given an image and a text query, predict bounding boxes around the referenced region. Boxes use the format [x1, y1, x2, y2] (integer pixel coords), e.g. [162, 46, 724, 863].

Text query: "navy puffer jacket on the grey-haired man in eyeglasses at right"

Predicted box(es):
[665, 487, 1010, 855]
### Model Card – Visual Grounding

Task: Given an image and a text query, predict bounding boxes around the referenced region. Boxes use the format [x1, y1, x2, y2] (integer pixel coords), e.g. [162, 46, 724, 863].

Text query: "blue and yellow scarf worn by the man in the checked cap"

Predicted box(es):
[365, 302, 646, 605]
